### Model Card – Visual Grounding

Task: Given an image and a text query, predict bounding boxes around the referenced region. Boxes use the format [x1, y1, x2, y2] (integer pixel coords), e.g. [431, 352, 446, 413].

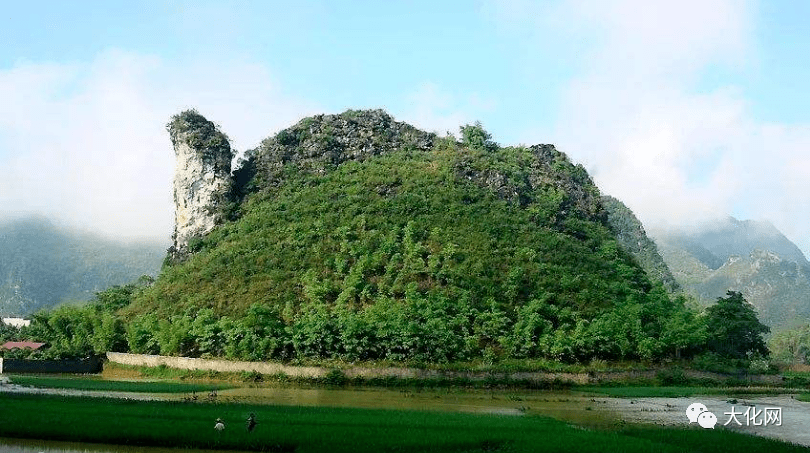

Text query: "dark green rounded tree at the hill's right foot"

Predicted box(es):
[706, 291, 771, 359]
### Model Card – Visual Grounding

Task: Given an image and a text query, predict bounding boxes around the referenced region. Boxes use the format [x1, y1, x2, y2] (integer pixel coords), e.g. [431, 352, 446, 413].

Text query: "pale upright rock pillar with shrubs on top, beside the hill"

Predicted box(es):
[167, 110, 233, 259]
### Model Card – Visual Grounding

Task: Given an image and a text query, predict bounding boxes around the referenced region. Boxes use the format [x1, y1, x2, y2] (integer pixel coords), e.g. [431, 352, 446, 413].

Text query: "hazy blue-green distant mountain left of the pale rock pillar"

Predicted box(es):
[0, 217, 166, 316]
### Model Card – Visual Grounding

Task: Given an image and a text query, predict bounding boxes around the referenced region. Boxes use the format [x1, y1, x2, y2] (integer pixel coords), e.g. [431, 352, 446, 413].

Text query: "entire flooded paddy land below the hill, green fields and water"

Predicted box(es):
[0, 370, 810, 453]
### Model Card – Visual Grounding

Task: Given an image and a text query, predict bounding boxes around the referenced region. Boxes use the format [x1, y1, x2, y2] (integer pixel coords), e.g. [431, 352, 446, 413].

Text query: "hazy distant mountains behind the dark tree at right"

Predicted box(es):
[650, 217, 810, 330]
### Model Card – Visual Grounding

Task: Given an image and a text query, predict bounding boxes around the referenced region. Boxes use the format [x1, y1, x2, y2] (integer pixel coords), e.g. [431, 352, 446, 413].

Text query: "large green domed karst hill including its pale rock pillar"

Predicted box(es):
[122, 110, 689, 361]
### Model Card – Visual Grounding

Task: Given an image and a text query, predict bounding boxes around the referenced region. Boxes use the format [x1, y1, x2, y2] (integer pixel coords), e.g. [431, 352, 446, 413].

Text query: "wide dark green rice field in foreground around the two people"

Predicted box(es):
[0, 394, 807, 453]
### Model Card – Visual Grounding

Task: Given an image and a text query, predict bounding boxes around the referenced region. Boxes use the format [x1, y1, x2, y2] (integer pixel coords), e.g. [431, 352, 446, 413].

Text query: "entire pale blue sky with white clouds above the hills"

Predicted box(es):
[0, 0, 810, 255]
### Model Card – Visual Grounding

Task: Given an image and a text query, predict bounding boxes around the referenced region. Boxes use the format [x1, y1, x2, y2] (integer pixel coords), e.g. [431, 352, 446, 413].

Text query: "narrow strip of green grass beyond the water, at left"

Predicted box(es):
[10, 375, 232, 393]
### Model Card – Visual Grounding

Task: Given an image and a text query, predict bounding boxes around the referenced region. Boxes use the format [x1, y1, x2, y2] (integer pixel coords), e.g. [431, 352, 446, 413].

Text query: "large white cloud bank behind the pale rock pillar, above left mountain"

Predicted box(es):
[0, 50, 316, 243]
